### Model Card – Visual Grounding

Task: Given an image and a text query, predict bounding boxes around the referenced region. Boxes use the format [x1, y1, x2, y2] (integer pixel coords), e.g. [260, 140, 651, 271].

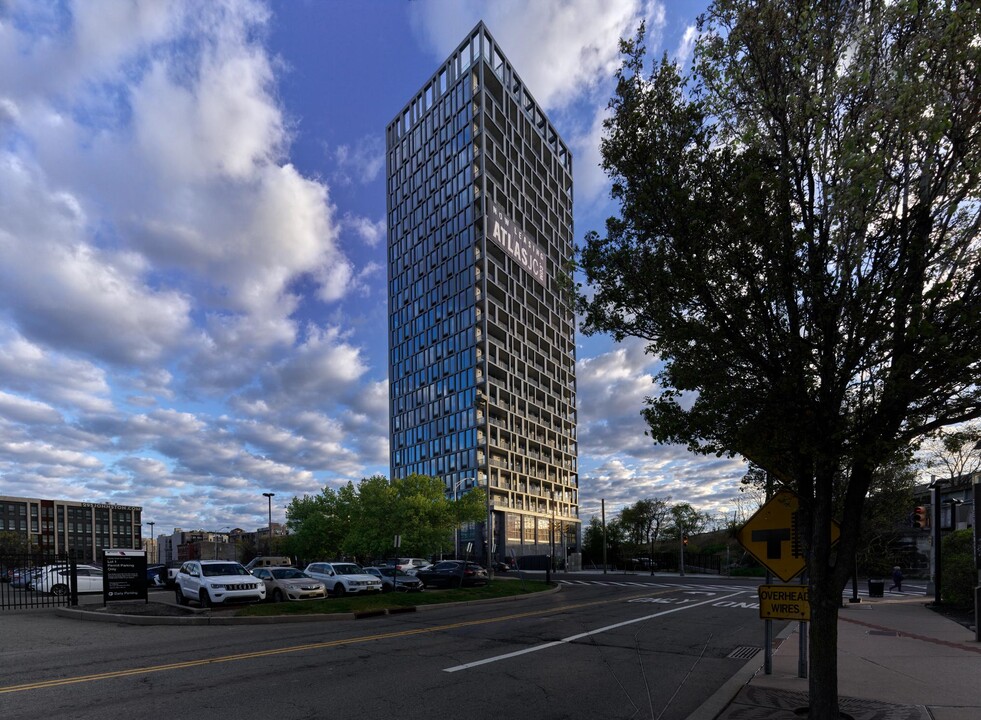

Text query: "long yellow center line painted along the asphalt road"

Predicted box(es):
[0, 590, 671, 695]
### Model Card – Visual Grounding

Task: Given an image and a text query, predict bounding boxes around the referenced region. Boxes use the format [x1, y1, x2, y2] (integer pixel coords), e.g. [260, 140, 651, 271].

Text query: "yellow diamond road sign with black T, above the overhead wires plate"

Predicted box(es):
[738, 490, 841, 582]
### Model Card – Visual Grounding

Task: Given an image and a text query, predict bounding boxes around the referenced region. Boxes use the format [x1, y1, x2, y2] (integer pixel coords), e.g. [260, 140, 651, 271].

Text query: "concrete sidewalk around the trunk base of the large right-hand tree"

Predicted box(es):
[689, 595, 981, 720]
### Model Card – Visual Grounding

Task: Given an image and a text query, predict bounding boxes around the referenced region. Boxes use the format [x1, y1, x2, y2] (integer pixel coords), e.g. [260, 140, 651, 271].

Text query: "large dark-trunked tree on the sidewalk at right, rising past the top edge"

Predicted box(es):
[579, 0, 981, 718]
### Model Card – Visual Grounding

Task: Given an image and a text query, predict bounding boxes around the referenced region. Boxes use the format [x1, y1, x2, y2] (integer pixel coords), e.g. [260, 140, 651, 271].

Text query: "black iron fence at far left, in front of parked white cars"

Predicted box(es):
[0, 551, 78, 610]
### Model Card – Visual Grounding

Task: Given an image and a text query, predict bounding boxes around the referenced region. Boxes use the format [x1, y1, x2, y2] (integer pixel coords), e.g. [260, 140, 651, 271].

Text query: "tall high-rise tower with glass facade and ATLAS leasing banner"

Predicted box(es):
[386, 23, 580, 563]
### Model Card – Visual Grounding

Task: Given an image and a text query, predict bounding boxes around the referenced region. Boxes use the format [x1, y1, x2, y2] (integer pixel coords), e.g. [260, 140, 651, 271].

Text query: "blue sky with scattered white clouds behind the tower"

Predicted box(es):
[0, 0, 744, 532]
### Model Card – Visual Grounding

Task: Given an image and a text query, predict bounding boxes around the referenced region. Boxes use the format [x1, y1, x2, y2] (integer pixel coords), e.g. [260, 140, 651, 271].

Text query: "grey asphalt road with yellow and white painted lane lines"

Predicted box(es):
[0, 575, 763, 720]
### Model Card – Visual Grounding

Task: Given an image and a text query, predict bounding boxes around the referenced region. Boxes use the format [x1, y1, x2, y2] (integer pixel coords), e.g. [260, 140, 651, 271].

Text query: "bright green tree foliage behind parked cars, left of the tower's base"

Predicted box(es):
[286, 475, 486, 560]
